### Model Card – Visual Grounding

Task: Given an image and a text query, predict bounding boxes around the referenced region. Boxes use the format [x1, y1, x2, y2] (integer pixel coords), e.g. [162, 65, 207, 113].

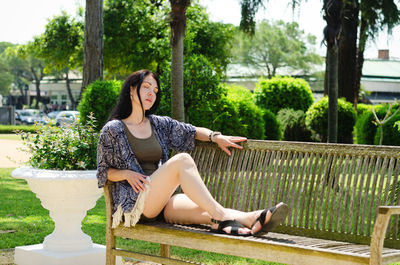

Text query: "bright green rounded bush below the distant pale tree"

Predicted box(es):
[254, 77, 314, 114]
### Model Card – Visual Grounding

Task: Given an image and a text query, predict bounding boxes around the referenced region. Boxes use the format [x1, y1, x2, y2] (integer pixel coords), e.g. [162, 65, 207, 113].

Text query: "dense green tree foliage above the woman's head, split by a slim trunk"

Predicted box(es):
[104, 0, 234, 78]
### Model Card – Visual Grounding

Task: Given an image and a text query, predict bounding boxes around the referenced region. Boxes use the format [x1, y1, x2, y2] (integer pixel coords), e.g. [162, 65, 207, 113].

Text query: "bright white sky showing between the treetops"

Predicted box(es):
[0, 0, 400, 59]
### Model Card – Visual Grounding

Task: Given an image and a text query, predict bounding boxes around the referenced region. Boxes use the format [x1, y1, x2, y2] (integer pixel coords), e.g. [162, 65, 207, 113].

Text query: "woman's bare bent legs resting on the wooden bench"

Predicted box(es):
[143, 153, 255, 233]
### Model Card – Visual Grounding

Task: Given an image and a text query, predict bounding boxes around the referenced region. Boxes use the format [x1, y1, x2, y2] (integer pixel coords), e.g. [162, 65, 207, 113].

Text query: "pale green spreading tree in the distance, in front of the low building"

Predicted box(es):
[236, 20, 322, 78]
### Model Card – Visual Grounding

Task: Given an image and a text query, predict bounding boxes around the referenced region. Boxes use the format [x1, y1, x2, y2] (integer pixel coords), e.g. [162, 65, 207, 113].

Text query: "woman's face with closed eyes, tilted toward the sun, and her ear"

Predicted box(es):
[131, 75, 158, 111]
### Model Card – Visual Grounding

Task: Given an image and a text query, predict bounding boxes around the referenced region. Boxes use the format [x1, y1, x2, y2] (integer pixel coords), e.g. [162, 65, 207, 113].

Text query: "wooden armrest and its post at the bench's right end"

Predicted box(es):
[370, 206, 400, 265]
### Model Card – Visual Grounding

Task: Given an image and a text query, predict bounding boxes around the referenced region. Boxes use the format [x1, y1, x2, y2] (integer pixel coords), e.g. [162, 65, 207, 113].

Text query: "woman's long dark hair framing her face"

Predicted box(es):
[108, 69, 161, 121]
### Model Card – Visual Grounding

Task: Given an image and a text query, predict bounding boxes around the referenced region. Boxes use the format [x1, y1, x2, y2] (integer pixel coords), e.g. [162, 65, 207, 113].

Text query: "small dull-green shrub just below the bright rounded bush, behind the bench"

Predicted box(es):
[277, 109, 312, 142]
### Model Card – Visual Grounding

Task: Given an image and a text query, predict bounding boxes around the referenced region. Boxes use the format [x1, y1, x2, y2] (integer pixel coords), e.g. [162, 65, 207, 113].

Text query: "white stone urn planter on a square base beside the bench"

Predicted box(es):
[11, 167, 115, 265]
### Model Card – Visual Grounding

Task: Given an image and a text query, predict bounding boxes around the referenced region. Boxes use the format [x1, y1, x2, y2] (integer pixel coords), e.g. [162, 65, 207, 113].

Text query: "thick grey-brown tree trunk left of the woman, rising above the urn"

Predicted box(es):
[80, 0, 103, 97]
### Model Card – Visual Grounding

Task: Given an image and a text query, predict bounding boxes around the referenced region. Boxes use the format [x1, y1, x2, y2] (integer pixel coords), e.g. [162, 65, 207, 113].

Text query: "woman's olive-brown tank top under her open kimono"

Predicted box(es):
[122, 123, 162, 176]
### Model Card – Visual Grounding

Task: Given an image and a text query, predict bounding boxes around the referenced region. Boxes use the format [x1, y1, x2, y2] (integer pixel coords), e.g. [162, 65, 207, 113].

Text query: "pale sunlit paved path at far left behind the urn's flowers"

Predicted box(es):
[0, 139, 29, 168]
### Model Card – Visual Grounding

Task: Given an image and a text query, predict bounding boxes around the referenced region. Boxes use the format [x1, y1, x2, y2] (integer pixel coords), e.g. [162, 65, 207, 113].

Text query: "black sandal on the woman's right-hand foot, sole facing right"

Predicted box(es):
[251, 202, 289, 235]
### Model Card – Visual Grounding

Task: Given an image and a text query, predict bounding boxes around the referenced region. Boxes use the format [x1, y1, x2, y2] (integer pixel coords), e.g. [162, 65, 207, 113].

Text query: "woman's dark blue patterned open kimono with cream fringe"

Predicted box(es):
[97, 115, 196, 228]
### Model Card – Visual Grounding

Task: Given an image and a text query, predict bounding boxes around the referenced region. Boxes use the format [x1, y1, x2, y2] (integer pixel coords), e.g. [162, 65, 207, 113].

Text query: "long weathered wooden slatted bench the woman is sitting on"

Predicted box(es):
[105, 140, 400, 265]
